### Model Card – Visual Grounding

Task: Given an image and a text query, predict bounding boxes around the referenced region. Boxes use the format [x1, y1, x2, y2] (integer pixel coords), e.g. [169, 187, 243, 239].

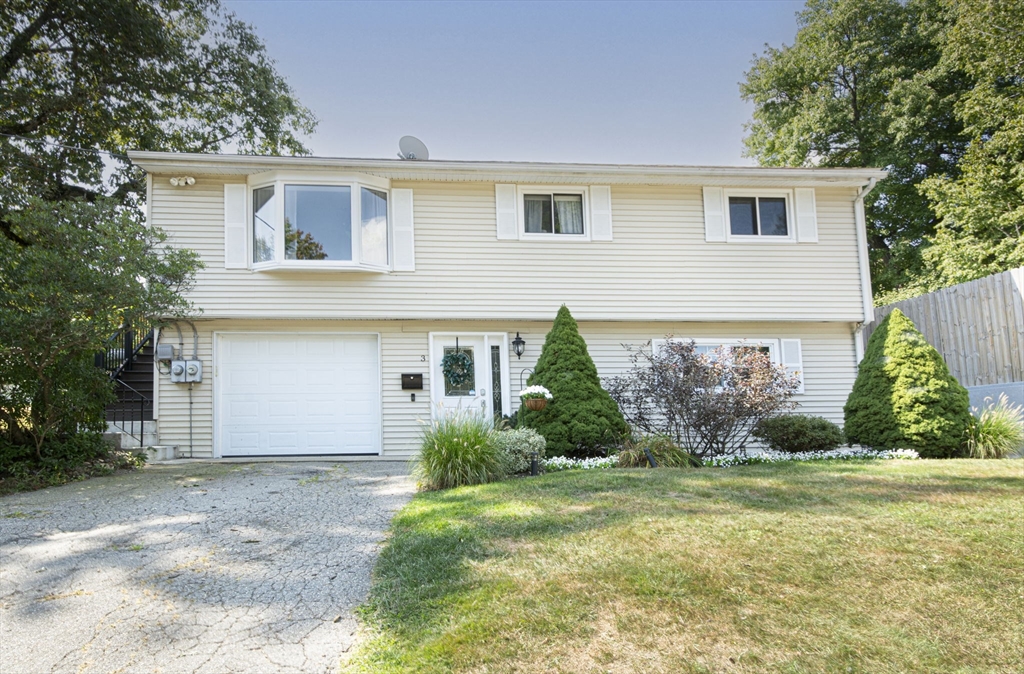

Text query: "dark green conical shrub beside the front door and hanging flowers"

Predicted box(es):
[519, 305, 629, 457]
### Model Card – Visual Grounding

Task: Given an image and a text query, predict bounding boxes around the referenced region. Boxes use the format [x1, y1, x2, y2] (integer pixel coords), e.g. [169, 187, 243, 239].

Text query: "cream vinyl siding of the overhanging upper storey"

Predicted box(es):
[152, 176, 863, 323]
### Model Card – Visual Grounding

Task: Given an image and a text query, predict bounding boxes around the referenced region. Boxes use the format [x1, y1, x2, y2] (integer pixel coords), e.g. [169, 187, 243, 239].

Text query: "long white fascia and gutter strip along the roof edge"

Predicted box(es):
[128, 151, 887, 187]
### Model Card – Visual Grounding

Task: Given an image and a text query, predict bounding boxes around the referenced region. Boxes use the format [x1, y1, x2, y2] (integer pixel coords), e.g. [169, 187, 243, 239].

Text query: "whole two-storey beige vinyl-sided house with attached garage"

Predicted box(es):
[132, 153, 885, 459]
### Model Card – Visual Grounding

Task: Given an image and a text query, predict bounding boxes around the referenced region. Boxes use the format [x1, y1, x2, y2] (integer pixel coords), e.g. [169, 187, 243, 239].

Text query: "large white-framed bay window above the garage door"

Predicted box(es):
[252, 180, 389, 269]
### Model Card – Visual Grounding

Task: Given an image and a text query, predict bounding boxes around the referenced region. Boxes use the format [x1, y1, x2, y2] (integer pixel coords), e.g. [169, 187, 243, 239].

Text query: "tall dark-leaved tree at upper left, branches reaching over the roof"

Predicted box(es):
[0, 0, 314, 222]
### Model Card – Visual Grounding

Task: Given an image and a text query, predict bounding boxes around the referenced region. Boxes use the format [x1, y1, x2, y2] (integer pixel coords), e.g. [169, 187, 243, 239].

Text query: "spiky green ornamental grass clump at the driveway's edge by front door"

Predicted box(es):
[416, 410, 506, 490]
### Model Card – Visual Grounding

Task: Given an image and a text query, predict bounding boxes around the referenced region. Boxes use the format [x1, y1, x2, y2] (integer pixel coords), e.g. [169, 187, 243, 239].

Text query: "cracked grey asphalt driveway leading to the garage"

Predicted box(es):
[0, 463, 414, 674]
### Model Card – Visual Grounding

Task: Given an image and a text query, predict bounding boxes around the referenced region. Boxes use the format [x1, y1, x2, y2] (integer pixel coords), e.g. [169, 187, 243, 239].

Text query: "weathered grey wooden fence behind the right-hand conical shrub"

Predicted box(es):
[864, 267, 1024, 386]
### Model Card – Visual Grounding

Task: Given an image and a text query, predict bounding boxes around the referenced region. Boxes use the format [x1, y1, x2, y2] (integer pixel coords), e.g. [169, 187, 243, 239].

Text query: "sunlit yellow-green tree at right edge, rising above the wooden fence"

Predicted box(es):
[917, 0, 1024, 294]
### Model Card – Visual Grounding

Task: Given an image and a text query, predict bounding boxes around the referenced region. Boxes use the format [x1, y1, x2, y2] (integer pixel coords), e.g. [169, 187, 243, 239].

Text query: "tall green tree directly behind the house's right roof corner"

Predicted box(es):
[740, 0, 969, 293]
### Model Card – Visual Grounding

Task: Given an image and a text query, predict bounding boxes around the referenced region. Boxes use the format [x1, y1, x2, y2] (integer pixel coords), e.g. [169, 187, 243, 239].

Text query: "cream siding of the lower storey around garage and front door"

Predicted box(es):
[155, 320, 856, 460]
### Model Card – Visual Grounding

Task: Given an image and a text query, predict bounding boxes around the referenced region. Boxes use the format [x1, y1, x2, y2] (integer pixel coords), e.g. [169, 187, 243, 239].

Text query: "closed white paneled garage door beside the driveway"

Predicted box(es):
[216, 334, 381, 457]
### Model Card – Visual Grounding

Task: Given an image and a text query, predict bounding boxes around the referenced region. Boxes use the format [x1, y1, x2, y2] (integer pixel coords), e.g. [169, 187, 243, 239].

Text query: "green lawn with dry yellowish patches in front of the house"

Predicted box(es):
[343, 460, 1024, 673]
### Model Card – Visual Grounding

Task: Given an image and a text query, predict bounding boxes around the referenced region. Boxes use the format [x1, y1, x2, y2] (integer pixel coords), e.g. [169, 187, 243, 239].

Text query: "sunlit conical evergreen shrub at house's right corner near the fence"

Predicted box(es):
[843, 309, 971, 458]
